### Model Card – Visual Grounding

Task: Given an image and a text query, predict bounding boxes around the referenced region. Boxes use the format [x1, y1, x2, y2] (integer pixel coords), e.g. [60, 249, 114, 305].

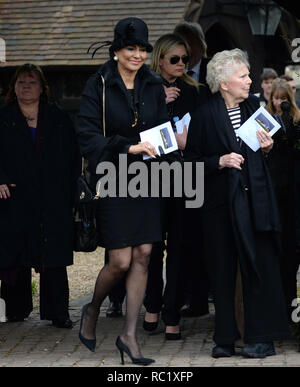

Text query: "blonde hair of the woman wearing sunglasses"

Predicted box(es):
[150, 34, 200, 88]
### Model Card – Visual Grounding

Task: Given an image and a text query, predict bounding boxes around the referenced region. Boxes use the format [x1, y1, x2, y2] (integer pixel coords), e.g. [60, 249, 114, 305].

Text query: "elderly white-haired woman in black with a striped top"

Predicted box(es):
[186, 49, 289, 358]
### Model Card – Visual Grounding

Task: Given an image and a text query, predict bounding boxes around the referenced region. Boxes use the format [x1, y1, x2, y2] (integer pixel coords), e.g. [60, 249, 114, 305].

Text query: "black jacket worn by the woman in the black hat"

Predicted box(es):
[77, 60, 169, 173]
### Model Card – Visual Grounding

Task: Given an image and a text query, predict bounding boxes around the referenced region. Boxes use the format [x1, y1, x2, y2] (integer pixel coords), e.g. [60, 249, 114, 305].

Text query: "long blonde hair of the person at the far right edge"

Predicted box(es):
[267, 78, 300, 124]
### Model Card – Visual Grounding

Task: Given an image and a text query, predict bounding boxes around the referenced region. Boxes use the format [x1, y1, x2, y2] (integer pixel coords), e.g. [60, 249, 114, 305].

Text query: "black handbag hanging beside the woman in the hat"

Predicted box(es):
[73, 163, 98, 253]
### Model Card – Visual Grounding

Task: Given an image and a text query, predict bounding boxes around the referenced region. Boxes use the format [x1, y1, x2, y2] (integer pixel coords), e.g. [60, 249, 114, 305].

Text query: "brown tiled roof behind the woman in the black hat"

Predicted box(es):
[0, 0, 188, 66]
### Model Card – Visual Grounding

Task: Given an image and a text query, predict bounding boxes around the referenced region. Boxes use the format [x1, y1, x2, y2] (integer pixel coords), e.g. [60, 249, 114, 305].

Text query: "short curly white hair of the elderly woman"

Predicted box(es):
[206, 48, 250, 93]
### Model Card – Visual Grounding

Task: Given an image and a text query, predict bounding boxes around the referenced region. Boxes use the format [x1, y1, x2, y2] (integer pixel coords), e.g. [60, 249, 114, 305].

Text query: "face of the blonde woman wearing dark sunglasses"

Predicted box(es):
[159, 44, 187, 82]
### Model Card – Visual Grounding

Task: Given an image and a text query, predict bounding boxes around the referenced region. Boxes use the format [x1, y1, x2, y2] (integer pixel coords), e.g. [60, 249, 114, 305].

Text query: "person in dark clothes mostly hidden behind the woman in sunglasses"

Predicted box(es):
[174, 21, 213, 317]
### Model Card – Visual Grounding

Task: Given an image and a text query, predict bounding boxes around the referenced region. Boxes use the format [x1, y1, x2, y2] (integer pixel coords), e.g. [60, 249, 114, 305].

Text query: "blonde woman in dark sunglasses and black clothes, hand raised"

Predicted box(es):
[143, 34, 206, 340]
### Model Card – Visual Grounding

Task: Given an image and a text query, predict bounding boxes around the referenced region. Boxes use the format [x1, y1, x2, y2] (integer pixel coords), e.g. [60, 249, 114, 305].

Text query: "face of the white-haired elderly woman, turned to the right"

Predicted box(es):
[220, 63, 252, 107]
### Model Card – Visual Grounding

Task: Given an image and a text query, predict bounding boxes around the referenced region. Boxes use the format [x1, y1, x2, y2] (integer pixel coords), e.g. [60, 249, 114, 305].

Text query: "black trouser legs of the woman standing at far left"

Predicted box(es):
[1, 267, 69, 320]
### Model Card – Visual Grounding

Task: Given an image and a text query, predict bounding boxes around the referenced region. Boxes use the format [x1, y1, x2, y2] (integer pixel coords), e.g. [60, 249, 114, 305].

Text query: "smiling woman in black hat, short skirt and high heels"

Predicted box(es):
[77, 18, 168, 365]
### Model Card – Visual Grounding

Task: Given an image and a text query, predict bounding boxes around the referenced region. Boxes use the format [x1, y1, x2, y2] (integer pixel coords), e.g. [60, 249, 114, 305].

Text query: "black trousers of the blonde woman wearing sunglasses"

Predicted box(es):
[144, 198, 184, 326]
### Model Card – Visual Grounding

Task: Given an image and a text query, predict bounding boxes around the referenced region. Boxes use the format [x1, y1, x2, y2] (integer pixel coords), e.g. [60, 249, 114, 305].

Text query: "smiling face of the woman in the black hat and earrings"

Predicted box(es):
[115, 46, 147, 73]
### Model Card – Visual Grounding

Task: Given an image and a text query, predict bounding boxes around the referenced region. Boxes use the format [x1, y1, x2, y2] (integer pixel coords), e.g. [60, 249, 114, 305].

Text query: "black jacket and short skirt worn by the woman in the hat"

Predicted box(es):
[77, 60, 168, 249]
